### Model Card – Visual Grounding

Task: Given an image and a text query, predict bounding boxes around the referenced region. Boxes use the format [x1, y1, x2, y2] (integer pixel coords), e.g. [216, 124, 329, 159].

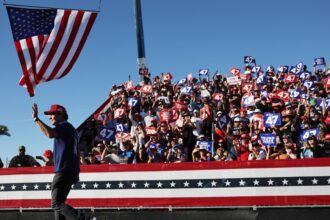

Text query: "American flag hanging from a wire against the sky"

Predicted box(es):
[7, 6, 97, 96]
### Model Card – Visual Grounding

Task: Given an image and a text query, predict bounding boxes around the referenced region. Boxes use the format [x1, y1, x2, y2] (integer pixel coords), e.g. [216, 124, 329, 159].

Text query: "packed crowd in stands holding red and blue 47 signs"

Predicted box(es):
[76, 57, 330, 164]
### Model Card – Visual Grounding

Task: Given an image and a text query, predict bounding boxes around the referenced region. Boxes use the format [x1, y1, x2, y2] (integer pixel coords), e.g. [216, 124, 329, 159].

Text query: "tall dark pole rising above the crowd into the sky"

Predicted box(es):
[134, 0, 147, 68]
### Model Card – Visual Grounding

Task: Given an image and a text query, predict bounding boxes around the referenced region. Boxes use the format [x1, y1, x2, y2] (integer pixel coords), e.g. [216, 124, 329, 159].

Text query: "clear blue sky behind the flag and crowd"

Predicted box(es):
[0, 0, 330, 165]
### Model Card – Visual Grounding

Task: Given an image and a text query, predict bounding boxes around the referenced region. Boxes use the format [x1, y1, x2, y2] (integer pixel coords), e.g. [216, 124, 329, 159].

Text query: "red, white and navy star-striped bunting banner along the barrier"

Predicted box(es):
[0, 158, 330, 208]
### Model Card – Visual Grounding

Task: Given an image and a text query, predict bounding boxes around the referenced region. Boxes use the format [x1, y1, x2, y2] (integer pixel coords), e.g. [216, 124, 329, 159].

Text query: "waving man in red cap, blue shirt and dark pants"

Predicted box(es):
[32, 104, 80, 220]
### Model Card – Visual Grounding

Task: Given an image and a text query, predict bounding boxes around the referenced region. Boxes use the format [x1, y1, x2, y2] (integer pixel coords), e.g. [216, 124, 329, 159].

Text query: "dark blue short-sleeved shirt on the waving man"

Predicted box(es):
[54, 122, 80, 173]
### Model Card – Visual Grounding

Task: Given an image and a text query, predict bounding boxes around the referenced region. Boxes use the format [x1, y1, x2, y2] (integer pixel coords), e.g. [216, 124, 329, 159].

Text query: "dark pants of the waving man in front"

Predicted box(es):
[52, 173, 79, 220]
